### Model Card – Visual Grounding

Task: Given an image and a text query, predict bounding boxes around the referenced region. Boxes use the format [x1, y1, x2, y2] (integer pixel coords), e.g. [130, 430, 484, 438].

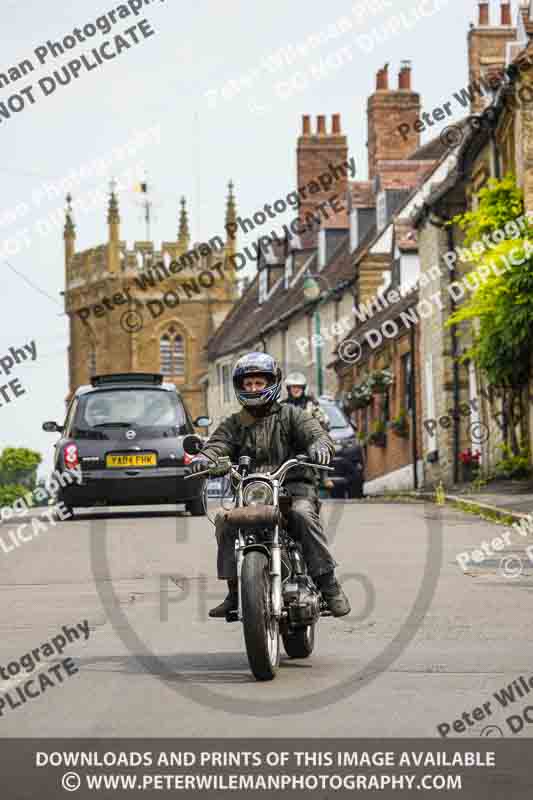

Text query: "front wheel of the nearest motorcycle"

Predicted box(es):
[241, 550, 280, 681]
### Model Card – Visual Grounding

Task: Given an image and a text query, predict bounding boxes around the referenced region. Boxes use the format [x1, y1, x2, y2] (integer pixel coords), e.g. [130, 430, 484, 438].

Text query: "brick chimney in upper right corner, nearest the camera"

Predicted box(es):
[468, 0, 516, 114]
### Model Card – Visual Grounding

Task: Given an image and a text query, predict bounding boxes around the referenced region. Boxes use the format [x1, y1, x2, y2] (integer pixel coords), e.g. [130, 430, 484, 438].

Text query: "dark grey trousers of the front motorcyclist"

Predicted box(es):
[215, 497, 336, 580]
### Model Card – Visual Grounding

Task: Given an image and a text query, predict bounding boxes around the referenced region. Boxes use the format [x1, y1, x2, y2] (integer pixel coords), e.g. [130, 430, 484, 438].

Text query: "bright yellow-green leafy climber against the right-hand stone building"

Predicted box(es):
[448, 175, 533, 455]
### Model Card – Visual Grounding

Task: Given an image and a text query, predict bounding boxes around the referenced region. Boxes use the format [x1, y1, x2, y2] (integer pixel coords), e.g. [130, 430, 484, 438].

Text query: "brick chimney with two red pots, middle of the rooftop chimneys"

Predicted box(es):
[367, 61, 421, 180]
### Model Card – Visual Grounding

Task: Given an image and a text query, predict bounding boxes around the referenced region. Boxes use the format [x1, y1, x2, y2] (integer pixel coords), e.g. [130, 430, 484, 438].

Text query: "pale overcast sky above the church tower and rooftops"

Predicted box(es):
[0, 0, 508, 476]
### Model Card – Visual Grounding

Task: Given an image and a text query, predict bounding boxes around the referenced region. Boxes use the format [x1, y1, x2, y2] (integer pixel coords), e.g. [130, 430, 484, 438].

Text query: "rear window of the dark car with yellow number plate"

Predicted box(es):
[72, 389, 187, 431]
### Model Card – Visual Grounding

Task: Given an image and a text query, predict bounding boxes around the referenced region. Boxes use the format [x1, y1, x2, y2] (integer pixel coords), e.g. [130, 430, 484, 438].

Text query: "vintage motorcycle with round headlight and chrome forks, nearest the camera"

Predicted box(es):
[183, 435, 332, 681]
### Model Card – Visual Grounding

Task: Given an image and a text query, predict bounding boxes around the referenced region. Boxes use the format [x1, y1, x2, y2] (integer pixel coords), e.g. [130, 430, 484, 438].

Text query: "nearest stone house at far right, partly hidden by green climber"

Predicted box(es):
[413, 3, 533, 486]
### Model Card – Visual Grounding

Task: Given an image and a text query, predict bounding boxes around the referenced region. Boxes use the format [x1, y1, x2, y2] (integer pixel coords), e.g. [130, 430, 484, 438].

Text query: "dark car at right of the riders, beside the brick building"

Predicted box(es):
[318, 396, 365, 498]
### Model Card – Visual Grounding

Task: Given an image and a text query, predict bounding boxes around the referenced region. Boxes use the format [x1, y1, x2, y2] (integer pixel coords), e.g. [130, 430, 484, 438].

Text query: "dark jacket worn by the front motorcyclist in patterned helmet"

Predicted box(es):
[201, 402, 335, 496]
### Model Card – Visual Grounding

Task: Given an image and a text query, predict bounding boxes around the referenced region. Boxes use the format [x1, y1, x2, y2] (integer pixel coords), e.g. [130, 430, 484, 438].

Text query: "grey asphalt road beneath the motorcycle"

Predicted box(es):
[0, 502, 533, 737]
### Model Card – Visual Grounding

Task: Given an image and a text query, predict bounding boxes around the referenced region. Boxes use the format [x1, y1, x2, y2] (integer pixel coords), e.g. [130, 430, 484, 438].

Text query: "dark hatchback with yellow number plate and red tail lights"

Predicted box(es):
[43, 373, 209, 516]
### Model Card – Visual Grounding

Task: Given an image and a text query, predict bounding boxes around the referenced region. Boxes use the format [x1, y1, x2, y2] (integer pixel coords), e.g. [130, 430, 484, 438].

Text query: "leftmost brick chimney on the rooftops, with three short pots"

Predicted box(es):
[296, 114, 353, 228]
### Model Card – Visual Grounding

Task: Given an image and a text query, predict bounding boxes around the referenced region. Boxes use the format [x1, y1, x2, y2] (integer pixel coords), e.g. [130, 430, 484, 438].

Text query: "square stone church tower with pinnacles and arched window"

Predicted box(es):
[64, 181, 238, 417]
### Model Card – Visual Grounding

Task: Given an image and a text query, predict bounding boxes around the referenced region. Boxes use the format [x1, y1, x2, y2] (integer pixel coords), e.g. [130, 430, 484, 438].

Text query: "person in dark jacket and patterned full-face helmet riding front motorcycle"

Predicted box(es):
[192, 352, 351, 617]
